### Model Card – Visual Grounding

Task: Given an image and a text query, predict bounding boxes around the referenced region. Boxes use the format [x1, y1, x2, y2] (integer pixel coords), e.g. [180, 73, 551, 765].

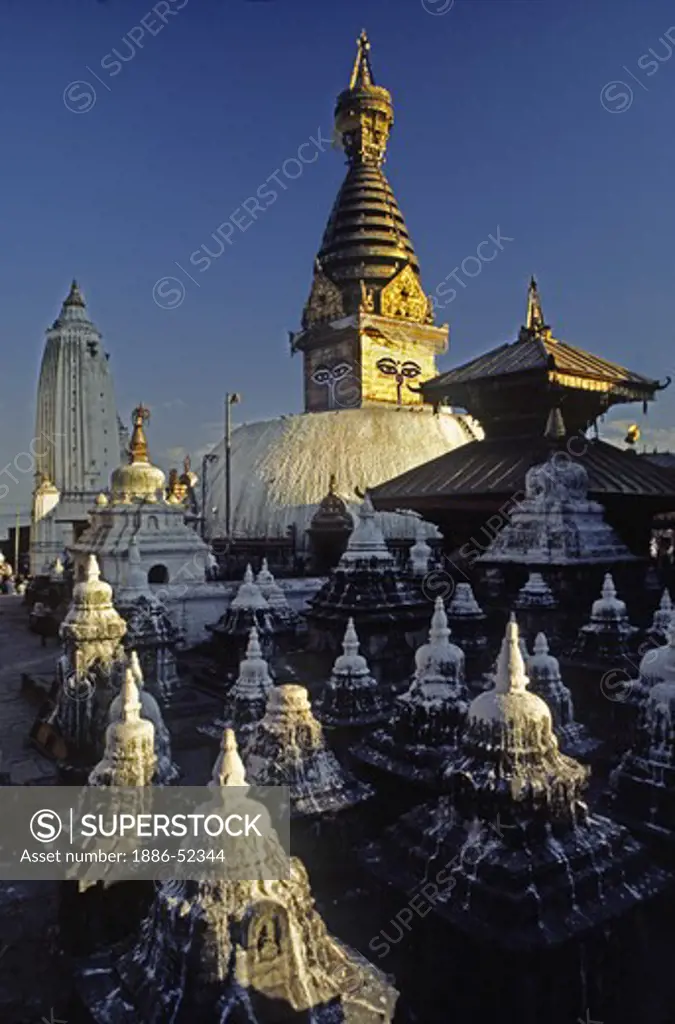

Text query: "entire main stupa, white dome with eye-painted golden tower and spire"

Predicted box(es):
[206, 33, 482, 547]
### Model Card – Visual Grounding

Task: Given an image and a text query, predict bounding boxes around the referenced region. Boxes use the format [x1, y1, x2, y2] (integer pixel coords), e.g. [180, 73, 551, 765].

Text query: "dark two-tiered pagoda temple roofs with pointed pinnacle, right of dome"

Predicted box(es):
[372, 279, 675, 554]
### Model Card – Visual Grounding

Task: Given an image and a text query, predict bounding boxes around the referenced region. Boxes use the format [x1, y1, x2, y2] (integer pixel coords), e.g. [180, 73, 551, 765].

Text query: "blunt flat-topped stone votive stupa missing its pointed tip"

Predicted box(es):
[244, 685, 373, 818]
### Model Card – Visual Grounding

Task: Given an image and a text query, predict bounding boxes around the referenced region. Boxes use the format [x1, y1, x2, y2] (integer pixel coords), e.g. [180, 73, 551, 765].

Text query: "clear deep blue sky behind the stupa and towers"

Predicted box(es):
[0, 0, 675, 511]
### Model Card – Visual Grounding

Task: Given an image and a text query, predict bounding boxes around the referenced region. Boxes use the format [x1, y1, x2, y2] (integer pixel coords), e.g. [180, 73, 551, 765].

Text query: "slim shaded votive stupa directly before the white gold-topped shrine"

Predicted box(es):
[115, 537, 181, 707]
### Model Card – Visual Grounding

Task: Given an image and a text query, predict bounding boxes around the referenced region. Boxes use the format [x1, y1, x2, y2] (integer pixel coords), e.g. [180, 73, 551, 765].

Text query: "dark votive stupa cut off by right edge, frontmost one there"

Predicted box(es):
[609, 659, 675, 843]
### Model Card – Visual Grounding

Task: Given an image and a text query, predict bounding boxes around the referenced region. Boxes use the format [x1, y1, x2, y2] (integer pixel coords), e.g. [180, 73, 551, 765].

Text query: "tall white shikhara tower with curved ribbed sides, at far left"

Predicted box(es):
[31, 281, 122, 572]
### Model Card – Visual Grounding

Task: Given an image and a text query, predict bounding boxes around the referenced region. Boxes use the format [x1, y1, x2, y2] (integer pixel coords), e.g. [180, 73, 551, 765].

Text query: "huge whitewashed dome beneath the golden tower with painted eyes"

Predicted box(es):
[207, 407, 482, 543]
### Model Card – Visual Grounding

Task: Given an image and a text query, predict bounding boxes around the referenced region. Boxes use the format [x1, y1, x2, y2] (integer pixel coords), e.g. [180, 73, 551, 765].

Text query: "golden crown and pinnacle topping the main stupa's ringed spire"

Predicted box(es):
[335, 31, 393, 167]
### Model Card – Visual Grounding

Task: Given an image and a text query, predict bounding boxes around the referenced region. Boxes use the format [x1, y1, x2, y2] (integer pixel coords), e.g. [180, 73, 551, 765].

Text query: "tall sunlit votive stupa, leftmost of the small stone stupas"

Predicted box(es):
[39, 555, 127, 781]
